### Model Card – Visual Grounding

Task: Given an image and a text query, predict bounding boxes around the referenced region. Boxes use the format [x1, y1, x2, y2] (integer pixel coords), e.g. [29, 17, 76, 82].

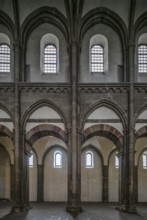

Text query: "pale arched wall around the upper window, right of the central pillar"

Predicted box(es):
[79, 23, 124, 83]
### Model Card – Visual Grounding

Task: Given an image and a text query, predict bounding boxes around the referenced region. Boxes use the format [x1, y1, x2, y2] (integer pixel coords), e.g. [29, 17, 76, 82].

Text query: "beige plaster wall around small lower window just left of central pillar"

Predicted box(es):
[44, 149, 67, 202]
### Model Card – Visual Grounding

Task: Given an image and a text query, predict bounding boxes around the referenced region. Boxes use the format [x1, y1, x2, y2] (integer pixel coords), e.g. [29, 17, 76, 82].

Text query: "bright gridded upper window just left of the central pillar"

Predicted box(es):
[44, 44, 57, 73]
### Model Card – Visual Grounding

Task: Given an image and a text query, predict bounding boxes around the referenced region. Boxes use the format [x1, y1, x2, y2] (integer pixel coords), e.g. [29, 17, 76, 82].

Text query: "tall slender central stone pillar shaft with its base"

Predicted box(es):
[67, 41, 81, 213]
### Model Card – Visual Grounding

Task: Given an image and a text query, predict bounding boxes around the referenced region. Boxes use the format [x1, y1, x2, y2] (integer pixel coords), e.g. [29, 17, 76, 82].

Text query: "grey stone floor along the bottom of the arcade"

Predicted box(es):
[0, 202, 147, 220]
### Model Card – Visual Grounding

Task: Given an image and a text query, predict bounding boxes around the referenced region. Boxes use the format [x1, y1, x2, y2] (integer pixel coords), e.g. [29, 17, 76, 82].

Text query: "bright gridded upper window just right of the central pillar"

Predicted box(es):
[91, 45, 104, 73]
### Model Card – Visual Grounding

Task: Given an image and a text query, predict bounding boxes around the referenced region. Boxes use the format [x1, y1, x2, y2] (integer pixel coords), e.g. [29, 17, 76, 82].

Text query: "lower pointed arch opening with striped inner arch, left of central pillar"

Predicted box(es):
[25, 105, 67, 202]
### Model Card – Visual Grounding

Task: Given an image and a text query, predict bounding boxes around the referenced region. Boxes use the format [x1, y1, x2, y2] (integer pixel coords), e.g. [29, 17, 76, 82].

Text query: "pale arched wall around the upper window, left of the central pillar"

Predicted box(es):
[24, 23, 69, 83]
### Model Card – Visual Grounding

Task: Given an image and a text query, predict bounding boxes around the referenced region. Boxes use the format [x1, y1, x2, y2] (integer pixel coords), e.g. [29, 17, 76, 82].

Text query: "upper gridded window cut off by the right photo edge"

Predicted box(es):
[138, 45, 147, 73]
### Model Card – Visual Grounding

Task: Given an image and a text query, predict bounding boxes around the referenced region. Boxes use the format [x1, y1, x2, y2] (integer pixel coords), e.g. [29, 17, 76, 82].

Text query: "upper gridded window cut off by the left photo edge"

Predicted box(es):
[0, 44, 10, 72]
